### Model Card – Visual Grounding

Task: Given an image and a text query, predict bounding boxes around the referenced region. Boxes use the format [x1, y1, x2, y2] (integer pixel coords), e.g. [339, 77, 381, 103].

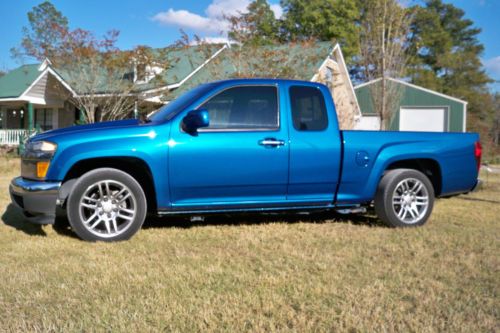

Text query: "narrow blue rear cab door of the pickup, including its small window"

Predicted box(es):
[287, 84, 342, 203]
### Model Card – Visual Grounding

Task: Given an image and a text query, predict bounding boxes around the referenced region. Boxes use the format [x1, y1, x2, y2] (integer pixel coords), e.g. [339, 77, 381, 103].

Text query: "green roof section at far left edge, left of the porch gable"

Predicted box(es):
[0, 64, 40, 98]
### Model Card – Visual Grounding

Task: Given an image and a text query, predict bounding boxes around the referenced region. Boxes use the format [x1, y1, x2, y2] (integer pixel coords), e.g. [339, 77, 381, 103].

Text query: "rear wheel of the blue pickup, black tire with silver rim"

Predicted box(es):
[375, 169, 434, 227]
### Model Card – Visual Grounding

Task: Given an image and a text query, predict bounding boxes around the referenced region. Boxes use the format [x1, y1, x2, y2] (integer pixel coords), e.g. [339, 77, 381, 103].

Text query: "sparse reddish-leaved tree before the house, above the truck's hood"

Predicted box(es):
[54, 29, 170, 122]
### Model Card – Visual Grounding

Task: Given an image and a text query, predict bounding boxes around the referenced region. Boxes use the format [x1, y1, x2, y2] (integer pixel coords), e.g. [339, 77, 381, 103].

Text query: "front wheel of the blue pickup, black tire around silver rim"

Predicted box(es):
[67, 168, 147, 242]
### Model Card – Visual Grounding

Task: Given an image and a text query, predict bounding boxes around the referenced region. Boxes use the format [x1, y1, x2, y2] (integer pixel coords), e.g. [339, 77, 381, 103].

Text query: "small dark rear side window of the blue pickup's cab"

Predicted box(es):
[290, 86, 328, 131]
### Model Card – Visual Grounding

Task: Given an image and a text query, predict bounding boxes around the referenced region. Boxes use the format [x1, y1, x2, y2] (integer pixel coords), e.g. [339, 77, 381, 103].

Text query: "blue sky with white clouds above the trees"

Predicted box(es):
[0, 0, 500, 91]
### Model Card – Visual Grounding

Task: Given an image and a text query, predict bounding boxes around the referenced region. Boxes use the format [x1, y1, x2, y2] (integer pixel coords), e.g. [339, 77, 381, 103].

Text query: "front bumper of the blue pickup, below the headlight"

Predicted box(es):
[9, 177, 61, 224]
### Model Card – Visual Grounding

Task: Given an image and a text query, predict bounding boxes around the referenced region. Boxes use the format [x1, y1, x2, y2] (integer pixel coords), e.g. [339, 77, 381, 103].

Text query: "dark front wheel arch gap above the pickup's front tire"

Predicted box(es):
[59, 156, 158, 212]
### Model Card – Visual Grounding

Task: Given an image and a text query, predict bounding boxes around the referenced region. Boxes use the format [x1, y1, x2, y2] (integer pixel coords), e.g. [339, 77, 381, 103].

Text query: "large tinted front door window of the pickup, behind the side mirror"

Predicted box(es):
[199, 86, 279, 130]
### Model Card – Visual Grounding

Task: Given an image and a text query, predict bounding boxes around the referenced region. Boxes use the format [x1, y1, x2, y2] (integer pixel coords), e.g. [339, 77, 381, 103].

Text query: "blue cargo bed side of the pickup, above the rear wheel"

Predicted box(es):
[336, 131, 479, 204]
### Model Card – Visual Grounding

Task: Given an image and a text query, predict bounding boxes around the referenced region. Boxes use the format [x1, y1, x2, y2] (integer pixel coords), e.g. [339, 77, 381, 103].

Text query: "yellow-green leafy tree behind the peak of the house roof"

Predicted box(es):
[281, 0, 359, 58]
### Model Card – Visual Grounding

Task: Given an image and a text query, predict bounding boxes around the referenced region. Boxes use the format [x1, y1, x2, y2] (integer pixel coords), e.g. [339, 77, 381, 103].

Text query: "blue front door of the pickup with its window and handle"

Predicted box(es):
[168, 85, 289, 209]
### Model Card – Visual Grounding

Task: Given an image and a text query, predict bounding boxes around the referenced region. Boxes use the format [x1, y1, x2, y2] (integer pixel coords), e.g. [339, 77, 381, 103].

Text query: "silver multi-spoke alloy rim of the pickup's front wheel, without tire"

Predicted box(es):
[79, 180, 137, 238]
